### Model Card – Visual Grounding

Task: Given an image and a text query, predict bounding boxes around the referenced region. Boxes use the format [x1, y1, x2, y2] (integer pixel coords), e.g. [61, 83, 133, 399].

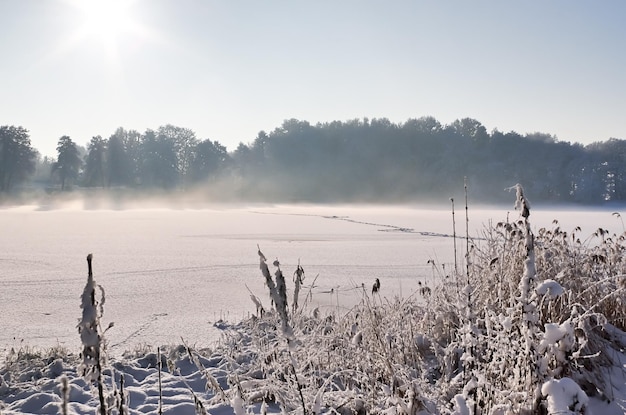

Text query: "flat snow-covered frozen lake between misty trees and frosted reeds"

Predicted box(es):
[0, 205, 623, 354]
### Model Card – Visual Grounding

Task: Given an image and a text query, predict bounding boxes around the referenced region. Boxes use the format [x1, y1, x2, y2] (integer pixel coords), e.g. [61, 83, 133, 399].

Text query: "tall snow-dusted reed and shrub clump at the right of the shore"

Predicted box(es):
[416, 186, 626, 413]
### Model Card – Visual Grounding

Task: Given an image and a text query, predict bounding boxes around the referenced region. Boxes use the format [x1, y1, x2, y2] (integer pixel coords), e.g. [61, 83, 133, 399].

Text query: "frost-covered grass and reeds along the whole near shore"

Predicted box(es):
[0, 199, 626, 415]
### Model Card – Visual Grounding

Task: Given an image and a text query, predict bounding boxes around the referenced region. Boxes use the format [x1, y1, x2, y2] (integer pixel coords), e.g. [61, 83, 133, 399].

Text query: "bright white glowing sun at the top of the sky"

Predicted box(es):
[71, 0, 139, 54]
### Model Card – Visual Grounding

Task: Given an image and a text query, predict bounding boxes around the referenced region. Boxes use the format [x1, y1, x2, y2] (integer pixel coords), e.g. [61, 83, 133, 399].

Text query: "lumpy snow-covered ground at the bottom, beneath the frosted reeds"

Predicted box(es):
[0, 308, 626, 415]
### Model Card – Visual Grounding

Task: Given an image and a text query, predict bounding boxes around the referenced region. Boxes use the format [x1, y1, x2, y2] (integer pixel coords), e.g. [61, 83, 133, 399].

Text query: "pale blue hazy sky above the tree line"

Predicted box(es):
[0, 0, 626, 156]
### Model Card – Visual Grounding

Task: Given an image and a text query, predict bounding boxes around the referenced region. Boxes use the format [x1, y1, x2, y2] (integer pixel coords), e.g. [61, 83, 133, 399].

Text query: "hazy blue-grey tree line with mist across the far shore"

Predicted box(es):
[0, 117, 626, 204]
